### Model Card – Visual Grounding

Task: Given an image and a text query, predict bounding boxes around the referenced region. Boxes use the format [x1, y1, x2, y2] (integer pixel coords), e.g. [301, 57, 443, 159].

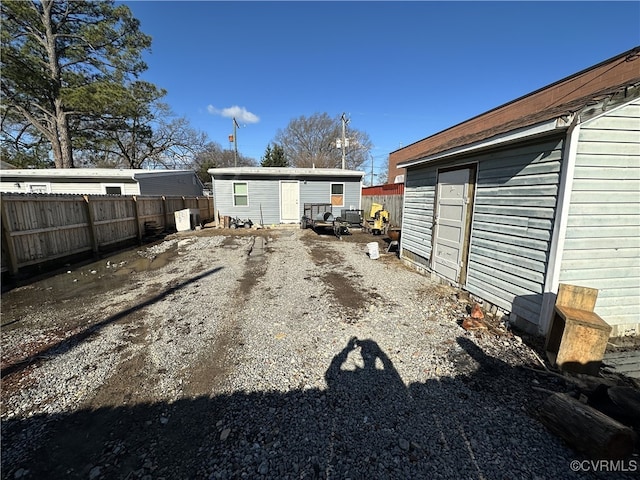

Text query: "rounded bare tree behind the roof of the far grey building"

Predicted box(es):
[275, 113, 371, 169]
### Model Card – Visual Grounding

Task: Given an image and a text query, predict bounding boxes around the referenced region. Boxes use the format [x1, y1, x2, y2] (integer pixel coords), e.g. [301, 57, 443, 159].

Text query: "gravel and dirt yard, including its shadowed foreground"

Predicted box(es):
[1, 229, 640, 480]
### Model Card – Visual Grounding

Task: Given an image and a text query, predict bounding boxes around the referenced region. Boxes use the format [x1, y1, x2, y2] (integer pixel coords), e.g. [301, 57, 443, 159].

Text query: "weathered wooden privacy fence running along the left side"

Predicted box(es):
[0, 194, 214, 274]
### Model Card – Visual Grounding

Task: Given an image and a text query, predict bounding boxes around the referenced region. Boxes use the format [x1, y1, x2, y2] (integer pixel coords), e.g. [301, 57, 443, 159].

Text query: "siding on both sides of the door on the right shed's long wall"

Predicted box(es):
[402, 137, 563, 324]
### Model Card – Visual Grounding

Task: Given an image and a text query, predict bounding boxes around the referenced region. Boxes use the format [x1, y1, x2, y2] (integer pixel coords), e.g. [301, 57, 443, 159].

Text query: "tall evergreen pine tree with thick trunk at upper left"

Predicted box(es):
[0, 0, 151, 168]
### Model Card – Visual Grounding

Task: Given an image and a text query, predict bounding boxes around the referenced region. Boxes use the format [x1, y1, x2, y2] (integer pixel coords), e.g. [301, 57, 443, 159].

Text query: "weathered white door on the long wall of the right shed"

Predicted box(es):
[431, 168, 471, 283]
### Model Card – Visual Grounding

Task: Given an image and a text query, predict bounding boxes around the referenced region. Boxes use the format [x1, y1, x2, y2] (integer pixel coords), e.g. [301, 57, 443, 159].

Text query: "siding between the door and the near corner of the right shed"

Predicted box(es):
[466, 138, 563, 324]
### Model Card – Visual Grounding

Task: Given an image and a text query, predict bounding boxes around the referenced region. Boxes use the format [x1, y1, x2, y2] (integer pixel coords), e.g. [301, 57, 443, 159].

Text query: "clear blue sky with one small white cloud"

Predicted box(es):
[123, 1, 640, 178]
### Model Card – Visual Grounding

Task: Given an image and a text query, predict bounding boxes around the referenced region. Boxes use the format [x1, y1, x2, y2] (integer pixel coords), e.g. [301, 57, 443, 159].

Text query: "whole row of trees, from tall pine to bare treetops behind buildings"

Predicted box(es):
[0, 0, 380, 185]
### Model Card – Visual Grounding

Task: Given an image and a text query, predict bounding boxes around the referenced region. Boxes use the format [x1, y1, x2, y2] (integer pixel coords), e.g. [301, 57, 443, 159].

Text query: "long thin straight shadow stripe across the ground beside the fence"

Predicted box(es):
[0, 267, 223, 378]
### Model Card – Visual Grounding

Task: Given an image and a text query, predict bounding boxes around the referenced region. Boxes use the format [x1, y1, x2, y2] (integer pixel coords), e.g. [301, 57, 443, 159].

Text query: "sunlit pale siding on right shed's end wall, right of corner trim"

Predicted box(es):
[560, 100, 640, 335]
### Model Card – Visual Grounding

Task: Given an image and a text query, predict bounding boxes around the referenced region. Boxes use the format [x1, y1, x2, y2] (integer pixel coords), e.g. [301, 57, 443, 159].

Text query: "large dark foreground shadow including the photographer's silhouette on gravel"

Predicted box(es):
[2, 337, 625, 480]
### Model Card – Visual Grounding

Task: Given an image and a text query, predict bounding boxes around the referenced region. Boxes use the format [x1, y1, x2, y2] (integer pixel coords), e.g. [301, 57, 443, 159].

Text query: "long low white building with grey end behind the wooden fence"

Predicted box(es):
[0, 168, 203, 196]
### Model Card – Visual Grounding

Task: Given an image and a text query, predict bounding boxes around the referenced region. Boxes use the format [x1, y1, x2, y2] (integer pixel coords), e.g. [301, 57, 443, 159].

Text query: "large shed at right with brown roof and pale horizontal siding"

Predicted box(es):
[390, 47, 640, 336]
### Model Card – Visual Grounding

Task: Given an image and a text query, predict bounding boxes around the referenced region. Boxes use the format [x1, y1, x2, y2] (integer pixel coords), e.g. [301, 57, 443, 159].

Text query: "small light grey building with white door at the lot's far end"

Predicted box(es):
[209, 167, 364, 225]
